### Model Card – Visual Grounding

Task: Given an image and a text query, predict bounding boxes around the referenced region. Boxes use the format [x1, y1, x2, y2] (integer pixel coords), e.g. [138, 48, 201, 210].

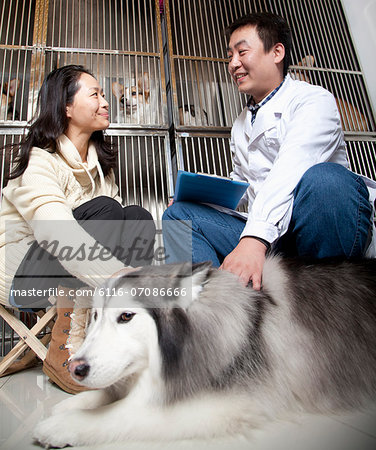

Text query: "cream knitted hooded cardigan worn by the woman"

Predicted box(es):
[0, 135, 124, 304]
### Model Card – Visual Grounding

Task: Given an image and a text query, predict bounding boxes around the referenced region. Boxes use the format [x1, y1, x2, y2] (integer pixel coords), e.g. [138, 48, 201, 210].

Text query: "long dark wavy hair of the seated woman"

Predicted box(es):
[8, 65, 116, 179]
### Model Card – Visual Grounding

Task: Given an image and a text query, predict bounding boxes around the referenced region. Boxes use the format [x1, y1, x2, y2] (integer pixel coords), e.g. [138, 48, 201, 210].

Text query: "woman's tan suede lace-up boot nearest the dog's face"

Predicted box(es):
[43, 287, 88, 394]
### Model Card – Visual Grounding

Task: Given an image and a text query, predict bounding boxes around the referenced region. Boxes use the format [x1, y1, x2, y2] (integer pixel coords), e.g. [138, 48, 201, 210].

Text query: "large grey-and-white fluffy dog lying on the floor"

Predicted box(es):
[34, 256, 376, 447]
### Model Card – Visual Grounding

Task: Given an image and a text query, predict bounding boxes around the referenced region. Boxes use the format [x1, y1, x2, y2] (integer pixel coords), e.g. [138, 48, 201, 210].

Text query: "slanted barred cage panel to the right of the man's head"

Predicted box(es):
[270, 0, 376, 133]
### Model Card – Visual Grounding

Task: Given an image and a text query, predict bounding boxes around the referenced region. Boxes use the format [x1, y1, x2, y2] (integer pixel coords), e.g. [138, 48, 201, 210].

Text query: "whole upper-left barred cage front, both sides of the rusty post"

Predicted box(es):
[0, 0, 167, 127]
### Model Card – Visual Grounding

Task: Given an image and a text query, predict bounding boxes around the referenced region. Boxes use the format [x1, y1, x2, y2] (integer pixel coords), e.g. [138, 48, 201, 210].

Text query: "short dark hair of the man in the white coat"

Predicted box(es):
[225, 12, 291, 76]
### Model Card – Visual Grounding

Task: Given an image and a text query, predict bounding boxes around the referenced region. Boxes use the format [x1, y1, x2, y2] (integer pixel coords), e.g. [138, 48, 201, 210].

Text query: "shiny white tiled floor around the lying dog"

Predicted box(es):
[0, 367, 376, 450]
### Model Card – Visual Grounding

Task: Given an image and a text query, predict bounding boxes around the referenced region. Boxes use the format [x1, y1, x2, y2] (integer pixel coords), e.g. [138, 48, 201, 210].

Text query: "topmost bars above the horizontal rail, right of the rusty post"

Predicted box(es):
[47, 0, 160, 53]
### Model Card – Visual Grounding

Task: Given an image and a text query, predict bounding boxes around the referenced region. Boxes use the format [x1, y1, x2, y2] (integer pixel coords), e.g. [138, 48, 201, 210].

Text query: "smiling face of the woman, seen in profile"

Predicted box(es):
[67, 73, 110, 135]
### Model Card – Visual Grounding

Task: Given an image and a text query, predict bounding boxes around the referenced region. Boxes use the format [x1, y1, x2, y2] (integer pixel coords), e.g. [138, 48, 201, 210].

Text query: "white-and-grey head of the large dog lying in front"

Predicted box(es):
[69, 263, 210, 388]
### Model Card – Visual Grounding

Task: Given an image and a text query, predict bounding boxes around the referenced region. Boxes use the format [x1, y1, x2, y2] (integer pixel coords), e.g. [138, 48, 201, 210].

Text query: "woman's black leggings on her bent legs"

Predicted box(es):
[11, 196, 155, 308]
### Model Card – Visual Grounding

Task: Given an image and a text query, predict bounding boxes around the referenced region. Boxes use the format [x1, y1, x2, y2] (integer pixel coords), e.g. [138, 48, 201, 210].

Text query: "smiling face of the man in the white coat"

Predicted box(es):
[227, 25, 284, 103]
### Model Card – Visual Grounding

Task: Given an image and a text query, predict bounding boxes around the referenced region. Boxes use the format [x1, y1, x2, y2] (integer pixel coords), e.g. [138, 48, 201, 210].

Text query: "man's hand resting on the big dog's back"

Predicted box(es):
[220, 237, 267, 291]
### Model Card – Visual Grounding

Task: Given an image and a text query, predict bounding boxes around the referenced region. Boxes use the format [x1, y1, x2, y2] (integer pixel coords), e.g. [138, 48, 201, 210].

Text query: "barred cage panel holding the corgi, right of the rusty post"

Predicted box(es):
[46, 0, 167, 128]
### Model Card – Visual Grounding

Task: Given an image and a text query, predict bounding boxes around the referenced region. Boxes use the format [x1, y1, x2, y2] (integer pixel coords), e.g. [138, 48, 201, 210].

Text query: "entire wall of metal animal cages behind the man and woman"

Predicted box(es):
[0, 0, 376, 356]
